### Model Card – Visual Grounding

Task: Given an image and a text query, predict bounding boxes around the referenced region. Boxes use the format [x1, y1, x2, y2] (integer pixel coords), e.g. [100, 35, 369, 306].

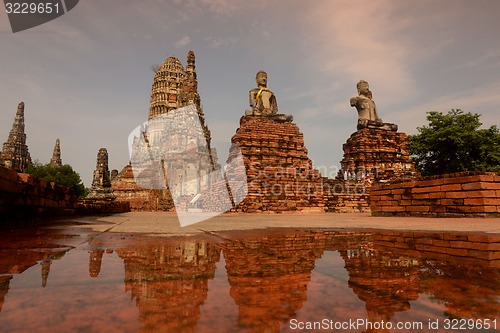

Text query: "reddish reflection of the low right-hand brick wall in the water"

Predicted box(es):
[372, 231, 500, 318]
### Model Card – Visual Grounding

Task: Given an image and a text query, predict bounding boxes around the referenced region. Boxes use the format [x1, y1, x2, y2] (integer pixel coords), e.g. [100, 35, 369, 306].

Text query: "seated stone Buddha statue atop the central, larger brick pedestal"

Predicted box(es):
[245, 71, 293, 121]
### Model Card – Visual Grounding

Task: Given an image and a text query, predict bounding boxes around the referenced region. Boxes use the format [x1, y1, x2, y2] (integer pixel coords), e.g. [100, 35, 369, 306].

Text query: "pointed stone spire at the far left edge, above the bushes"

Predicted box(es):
[0, 102, 31, 172]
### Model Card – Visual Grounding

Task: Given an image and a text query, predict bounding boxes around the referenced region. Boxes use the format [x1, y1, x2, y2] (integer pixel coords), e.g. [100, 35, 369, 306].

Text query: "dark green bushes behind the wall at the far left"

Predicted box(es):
[24, 161, 87, 198]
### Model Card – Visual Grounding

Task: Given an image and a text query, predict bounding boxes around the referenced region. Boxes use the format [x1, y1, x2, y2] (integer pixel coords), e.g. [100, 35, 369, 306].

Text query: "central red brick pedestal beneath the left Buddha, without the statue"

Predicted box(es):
[229, 116, 326, 213]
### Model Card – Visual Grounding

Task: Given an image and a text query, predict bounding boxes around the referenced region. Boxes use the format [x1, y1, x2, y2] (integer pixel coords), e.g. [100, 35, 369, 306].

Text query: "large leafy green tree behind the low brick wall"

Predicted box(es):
[408, 109, 500, 176]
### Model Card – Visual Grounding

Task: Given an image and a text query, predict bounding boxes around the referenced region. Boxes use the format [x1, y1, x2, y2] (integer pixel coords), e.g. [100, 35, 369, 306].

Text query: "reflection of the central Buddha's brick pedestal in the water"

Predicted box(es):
[223, 230, 325, 332]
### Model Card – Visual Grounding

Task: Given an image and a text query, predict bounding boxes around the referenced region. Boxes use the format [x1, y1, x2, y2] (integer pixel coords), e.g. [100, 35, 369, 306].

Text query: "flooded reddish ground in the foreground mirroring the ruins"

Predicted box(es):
[0, 219, 500, 332]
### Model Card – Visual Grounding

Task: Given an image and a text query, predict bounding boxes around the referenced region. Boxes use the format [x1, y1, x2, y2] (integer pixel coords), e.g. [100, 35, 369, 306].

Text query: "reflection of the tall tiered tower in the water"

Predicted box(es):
[116, 238, 220, 332]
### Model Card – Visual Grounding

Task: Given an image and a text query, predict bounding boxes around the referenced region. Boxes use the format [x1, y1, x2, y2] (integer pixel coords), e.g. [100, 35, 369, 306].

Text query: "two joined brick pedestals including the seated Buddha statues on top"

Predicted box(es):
[223, 76, 417, 212]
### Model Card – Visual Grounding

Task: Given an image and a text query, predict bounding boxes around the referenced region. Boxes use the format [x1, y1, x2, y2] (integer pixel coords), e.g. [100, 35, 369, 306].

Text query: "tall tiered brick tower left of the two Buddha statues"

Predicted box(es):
[112, 51, 219, 210]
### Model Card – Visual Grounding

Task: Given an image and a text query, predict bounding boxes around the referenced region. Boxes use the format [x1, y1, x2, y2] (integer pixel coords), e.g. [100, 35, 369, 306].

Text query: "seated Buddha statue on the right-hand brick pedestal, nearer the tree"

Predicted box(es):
[350, 80, 398, 131]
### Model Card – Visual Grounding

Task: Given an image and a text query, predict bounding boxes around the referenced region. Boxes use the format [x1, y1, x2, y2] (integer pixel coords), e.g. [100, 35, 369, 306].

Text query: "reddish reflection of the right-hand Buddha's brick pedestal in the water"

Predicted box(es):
[340, 244, 420, 332]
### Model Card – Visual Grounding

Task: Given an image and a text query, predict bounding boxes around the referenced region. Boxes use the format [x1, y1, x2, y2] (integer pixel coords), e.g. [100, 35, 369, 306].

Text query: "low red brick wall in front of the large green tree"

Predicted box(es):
[370, 172, 500, 217]
